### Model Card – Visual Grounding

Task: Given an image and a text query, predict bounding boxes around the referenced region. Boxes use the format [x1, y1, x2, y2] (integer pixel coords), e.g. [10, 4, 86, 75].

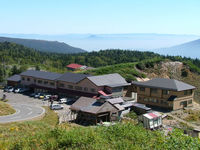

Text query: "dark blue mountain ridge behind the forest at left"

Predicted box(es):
[0, 37, 86, 54]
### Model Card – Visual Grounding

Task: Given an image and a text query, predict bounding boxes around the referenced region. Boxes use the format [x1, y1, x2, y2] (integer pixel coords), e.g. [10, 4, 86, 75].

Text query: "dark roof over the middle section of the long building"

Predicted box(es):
[57, 72, 90, 83]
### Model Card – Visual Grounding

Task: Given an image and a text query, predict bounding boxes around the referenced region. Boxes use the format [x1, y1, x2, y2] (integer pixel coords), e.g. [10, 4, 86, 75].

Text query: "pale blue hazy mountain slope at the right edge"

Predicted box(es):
[155, 39, 200, 58]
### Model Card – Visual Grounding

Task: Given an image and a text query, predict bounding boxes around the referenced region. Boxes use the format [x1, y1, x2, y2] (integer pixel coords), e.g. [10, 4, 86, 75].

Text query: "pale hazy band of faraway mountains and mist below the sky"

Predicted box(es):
[0, 33, 200, 51]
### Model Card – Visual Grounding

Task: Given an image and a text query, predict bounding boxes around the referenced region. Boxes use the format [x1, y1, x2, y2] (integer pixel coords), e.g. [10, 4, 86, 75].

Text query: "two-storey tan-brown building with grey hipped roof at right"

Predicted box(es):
[129, 78, 195, 110]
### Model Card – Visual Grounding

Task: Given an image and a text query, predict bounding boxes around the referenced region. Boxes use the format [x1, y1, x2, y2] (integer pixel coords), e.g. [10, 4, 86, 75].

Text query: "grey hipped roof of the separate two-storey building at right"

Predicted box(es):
[132, 78, 195, 91]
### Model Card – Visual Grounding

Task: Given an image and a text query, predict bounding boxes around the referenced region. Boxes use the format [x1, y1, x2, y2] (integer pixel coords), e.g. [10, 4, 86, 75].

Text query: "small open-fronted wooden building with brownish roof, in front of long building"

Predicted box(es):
[70, 97, 125, 125]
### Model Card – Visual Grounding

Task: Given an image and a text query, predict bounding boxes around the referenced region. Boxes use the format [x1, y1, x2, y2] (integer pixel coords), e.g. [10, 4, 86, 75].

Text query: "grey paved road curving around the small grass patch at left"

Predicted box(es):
[0, 90, 47, 123]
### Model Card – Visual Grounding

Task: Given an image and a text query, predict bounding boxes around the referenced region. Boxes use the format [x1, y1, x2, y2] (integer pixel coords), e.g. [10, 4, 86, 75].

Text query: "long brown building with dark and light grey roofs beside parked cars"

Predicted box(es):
[20, 70, 129, 97]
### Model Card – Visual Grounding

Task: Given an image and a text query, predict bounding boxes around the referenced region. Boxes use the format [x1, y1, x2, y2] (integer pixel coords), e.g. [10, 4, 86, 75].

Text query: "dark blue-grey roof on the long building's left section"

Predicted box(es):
[20, 70, 62, 80]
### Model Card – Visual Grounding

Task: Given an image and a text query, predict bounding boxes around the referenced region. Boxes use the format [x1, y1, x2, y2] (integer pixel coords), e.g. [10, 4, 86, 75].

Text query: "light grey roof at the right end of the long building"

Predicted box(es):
[88, 73, 127, 86]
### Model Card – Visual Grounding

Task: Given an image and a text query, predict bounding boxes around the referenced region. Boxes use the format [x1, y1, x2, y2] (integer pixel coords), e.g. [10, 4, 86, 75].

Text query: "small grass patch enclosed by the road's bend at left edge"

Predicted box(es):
[0, 101, 15, 116]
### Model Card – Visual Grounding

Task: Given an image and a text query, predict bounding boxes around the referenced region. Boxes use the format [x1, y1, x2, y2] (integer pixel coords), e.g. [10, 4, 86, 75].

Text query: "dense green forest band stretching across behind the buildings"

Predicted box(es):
[0, 42, 200, 81]
